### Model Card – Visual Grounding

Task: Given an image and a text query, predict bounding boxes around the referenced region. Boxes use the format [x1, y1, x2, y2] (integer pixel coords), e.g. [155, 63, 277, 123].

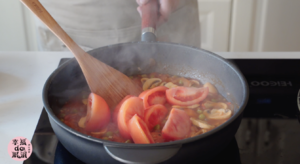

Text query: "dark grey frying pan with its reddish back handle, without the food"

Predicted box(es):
[43, 0, 248, 164]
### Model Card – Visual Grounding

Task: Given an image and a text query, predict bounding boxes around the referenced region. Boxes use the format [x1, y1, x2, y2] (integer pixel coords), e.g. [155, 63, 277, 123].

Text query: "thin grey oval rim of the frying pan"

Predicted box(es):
[42, 41, 249, 148]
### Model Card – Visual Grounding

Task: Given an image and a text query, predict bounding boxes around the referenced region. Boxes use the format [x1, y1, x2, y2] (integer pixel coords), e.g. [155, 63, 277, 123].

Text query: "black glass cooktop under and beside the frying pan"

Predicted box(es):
[24, 59, 300, 164]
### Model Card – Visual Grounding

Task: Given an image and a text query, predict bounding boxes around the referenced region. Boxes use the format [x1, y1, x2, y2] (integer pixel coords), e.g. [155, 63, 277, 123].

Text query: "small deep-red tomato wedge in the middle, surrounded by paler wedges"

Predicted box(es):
[144, 104, 168, 130]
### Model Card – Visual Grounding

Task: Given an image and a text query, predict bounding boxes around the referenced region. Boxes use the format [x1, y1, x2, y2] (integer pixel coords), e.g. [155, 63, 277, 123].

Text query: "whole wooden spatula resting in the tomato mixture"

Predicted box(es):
[21, 0, 142, 107]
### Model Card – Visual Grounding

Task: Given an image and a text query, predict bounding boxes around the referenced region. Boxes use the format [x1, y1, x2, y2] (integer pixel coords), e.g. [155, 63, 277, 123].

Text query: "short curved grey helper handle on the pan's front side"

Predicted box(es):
[104, 145, 181, 164]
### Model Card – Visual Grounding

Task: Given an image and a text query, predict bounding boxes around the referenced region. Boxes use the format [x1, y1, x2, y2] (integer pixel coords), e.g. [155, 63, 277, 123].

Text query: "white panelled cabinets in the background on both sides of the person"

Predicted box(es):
[0, 0, 300, 51]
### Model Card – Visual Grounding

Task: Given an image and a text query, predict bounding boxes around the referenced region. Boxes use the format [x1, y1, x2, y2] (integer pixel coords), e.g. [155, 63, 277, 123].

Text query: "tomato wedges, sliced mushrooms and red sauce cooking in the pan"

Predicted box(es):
[58, 73, 233, 144]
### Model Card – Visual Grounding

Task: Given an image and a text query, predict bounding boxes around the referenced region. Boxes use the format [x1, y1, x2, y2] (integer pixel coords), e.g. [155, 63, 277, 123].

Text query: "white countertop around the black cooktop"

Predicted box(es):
[0, 52, 300, 164]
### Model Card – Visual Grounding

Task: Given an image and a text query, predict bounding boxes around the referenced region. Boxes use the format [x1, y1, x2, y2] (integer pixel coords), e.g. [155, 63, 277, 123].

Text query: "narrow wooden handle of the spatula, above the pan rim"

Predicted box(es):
[20, 0, 85, 58]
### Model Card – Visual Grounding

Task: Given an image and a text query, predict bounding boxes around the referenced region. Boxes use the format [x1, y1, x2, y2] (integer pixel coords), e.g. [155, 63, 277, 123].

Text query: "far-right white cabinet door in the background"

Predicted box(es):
[229, 0, 300, 51]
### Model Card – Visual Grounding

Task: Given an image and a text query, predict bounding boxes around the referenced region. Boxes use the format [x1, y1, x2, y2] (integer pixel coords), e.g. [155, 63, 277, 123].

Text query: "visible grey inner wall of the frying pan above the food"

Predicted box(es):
[45, 42, 247, 142]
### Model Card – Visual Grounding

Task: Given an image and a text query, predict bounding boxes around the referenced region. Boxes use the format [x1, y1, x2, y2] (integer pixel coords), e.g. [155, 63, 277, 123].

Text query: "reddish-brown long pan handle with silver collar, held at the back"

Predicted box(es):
[141, 0, 158, 42]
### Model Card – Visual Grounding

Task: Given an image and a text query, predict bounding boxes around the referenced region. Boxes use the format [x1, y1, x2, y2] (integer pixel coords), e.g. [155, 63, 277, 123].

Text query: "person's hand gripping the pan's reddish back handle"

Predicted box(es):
[136, 0, 182, 26]
